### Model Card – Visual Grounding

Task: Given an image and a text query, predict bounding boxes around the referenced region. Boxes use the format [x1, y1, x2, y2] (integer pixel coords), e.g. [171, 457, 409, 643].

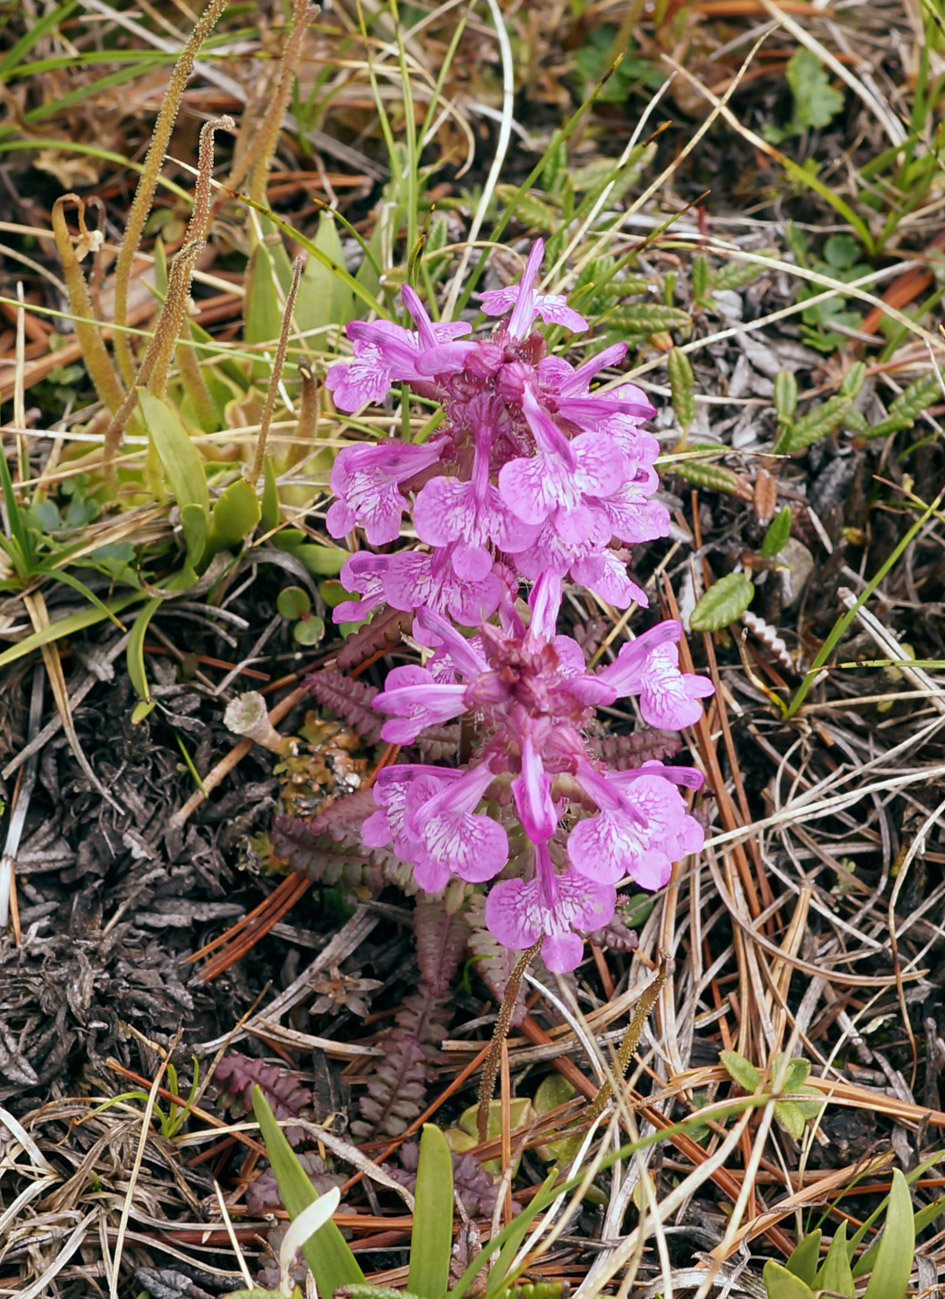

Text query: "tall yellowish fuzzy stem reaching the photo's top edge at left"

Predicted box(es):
[114, 0, 226, 385]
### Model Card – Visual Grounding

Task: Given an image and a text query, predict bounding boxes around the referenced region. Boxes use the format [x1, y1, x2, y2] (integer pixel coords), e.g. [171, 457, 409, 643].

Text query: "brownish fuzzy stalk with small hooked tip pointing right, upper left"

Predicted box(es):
[104, 117, 235, 486]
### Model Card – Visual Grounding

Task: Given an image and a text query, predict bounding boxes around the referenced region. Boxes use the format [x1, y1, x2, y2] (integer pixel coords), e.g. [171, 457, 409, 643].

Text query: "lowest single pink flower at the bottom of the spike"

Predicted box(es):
[486, 844, 616, 972]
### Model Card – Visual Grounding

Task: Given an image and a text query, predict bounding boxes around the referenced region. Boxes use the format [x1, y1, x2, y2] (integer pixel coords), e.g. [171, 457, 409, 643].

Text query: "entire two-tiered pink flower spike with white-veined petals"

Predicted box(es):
[321, 242, 712, 970]
